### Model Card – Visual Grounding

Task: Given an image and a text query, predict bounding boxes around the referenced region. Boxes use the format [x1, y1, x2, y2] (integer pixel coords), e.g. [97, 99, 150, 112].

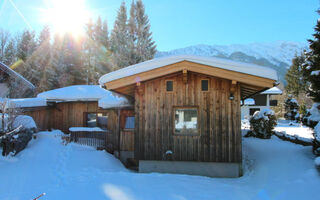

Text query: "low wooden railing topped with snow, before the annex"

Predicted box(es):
[70, 128, 108, 149]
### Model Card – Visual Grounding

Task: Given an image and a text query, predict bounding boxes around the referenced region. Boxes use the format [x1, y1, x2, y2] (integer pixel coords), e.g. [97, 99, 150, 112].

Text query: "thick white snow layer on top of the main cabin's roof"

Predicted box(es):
[99, 55, 278, 85]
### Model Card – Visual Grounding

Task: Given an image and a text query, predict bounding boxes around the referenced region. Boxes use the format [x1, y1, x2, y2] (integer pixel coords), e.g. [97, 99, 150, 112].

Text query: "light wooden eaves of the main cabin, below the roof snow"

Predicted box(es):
[105, 61, 276, 99]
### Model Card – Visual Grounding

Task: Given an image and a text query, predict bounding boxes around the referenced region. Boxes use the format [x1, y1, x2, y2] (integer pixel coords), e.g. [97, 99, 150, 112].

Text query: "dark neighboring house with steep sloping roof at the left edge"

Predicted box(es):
[0, 62, 35, 98]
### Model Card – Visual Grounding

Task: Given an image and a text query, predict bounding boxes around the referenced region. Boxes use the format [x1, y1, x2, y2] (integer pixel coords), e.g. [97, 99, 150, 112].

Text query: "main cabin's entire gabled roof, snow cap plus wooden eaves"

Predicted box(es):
[99, 56, 278, 99]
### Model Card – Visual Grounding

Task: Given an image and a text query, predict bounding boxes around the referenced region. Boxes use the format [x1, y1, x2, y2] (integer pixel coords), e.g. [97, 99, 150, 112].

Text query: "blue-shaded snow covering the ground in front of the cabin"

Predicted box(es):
[0, 131, 320, 200]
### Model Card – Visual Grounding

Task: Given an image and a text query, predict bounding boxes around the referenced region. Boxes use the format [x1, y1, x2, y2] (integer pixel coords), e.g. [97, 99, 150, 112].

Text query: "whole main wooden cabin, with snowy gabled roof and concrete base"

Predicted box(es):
[99, 56, 278, 177]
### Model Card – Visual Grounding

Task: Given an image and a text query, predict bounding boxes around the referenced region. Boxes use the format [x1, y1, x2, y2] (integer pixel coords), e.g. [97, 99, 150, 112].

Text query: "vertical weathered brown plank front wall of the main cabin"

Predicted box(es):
[135, 72, 242, 162]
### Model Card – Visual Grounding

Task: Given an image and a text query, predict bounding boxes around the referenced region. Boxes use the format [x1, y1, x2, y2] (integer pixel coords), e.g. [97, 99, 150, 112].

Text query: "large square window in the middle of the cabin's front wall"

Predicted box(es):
[175, 108, 198, 135]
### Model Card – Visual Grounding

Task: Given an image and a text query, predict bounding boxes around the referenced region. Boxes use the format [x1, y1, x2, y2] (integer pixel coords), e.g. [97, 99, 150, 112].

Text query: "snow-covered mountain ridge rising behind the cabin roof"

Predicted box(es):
[156, 41, 307, 82]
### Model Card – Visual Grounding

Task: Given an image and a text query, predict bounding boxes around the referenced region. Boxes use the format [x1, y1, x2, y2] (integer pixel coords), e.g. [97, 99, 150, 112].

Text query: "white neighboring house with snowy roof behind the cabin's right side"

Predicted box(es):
[241, 87, 282, 119]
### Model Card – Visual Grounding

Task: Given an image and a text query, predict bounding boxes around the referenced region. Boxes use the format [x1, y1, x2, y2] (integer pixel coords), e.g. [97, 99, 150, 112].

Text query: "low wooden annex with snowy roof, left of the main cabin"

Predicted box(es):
[19, 85, 133, 152]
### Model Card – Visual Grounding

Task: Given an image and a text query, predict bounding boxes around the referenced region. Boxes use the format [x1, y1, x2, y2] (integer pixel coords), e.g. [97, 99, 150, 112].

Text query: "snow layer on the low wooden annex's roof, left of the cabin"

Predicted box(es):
[38, 85, 131, 108]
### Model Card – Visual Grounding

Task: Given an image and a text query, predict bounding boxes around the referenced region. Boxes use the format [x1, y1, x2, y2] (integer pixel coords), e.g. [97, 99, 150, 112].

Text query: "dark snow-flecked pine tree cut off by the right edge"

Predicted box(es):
[303, 10, 320, 102]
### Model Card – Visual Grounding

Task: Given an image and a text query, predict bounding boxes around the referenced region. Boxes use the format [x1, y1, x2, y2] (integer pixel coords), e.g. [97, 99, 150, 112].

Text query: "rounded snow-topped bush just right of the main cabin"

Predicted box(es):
[246, 109, 277, 139]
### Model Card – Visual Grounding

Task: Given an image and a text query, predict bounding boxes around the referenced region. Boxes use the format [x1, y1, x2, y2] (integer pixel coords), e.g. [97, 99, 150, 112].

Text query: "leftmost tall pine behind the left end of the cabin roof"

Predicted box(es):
[110, 1, 130, 69]
